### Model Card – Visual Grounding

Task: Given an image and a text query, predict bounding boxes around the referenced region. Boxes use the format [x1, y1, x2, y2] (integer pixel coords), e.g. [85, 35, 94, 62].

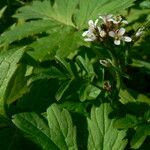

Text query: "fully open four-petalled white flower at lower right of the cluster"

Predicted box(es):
[109, 28, 132, 45]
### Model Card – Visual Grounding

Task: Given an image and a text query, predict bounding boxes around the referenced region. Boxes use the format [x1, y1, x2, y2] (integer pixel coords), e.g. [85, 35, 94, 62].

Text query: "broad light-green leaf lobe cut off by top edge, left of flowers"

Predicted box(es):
[14, 0, 78, 26]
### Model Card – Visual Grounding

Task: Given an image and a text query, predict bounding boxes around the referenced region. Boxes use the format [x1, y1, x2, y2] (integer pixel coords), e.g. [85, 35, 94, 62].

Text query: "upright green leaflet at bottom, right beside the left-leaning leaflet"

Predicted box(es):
[47, 104, 78, 150]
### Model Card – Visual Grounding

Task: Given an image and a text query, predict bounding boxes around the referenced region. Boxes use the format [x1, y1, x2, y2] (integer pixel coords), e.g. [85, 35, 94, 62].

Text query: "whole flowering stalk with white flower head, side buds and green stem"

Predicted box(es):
[82, 14, 144, 89]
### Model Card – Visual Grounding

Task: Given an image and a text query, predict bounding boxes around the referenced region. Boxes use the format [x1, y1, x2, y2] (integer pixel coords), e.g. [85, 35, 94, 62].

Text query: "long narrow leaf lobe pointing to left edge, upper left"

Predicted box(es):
[0, 20, 58, 44]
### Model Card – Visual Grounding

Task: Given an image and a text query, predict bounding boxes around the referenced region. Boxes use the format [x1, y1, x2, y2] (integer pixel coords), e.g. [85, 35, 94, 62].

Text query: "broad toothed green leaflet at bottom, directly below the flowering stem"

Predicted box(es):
[87, 104, 127, 150]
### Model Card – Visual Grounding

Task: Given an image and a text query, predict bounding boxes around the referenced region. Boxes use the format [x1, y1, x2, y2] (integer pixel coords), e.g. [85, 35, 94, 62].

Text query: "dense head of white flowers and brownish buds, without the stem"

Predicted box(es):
[82, 14, 132, 45]
